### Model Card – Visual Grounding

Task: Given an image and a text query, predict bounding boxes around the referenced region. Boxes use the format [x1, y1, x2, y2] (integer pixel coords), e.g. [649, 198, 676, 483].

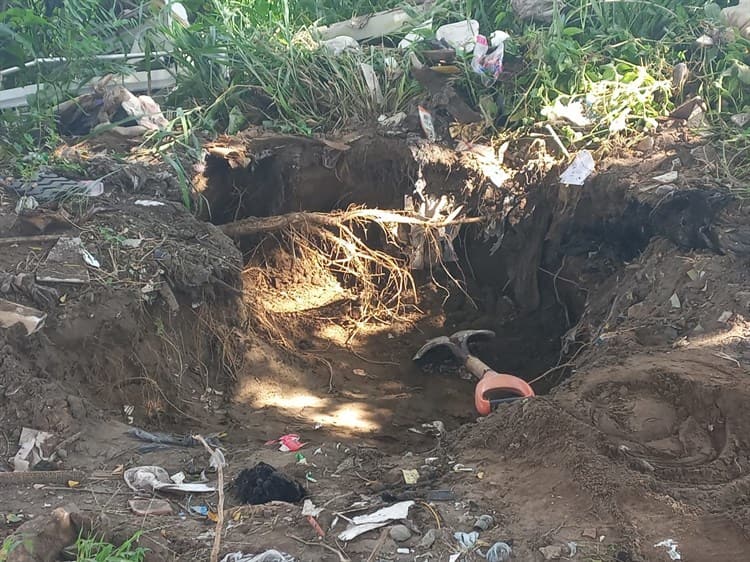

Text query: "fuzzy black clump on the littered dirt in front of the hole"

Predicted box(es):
[234, 462, 307, 505]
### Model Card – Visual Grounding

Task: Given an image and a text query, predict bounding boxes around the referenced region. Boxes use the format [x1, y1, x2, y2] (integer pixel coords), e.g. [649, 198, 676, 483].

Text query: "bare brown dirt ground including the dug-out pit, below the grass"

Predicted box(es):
[0, 135, 750, 562]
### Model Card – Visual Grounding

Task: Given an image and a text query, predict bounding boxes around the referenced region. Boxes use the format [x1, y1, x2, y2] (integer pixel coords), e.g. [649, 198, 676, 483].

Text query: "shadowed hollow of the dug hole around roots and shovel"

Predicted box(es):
[195, 133, 702, 448]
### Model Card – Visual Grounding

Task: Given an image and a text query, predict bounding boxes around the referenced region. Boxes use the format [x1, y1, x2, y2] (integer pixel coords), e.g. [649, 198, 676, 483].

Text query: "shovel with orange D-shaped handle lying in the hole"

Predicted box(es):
[414, 330, 534, 416]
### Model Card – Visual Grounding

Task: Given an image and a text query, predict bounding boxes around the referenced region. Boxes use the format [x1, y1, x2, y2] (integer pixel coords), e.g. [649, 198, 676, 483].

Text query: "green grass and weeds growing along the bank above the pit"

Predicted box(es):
[0, 0, 750, 201]
